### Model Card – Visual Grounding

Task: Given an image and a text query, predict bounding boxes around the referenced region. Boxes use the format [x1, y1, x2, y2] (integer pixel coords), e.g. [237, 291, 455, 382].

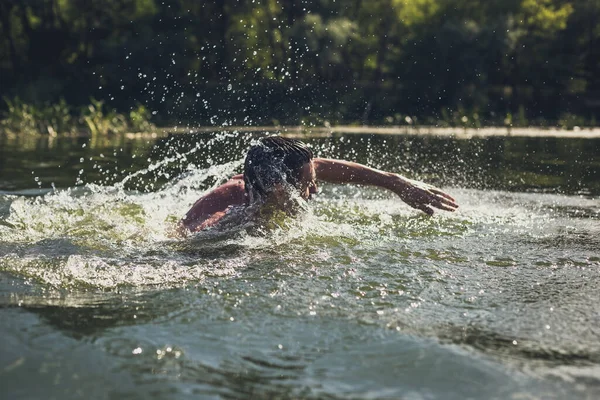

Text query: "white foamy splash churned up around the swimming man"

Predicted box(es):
[0, 132, 466, 289]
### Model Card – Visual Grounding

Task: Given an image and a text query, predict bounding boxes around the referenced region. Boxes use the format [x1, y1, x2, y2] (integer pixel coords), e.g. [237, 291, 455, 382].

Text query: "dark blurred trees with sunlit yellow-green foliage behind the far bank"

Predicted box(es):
[0, 0, 600, 128]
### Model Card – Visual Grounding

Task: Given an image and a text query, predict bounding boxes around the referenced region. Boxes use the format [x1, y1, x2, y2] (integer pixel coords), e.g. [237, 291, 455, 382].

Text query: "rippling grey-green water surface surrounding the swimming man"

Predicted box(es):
[0, 132, 600, 399]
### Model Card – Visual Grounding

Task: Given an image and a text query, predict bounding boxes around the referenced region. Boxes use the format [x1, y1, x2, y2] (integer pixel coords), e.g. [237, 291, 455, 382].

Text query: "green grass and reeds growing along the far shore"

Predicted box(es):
[0, 97, 597, 138]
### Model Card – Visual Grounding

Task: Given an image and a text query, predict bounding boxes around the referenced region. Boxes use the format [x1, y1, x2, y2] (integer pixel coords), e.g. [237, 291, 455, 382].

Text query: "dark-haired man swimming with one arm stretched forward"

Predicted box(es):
[179, 136, 458, 232]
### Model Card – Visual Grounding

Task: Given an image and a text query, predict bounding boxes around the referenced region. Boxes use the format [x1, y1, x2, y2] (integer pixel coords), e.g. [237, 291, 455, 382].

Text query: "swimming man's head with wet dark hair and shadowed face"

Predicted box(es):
[244, 136, 316, 202]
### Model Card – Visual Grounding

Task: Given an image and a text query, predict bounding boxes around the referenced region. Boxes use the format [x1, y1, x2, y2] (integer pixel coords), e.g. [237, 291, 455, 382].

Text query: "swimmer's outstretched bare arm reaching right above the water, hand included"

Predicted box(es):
[313, 158, 458, 215]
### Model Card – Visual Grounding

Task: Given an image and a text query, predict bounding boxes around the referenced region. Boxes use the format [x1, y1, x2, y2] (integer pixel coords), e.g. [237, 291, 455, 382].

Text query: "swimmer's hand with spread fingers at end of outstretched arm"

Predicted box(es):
[389, 174, 458, 215]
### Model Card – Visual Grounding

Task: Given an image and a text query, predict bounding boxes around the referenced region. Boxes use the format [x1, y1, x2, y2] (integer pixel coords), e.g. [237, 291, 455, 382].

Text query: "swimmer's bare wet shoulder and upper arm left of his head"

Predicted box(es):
[178, 174, 246, 233]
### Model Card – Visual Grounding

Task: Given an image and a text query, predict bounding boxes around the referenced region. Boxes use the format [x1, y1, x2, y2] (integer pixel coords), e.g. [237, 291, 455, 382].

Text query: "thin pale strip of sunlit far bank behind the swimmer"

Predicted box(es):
[163, 125, 600, 139]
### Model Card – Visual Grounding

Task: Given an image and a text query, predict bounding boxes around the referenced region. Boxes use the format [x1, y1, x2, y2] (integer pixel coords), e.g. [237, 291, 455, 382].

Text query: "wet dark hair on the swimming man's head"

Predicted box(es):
[244, 136, 313, 197]
